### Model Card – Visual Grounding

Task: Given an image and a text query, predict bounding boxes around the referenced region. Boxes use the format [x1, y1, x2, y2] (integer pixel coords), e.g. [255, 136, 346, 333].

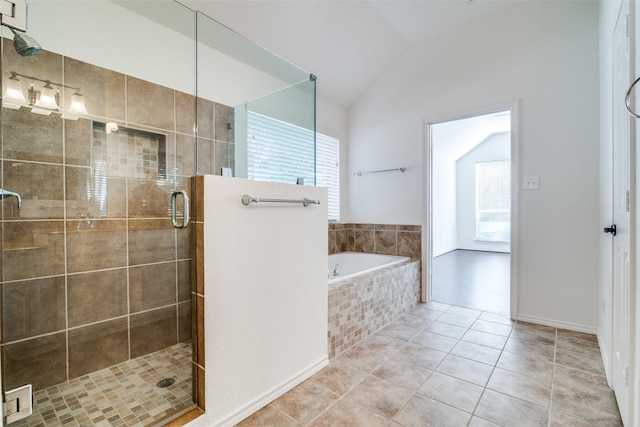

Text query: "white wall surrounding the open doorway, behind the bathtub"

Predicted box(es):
[348, 1, 601, 331]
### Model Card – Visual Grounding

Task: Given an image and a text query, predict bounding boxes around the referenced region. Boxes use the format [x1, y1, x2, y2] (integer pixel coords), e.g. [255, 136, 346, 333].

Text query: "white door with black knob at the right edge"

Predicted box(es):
[612, 1, 635, 424]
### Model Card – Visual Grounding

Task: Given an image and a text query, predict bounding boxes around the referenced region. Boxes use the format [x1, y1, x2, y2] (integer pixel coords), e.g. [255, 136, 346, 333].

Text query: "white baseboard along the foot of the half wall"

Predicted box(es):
[212, 356, 329, 427]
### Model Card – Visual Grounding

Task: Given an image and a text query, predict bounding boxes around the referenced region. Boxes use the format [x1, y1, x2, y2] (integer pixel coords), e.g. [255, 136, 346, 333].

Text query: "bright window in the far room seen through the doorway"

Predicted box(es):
[476, 160, 511, 242]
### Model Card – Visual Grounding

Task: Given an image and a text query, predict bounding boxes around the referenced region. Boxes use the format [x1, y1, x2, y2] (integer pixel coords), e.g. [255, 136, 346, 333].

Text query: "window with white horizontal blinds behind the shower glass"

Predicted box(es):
[247, 111, 340, 221]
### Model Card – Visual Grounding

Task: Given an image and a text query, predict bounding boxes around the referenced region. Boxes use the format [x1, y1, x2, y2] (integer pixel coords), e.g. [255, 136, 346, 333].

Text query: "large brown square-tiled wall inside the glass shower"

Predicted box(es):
[1, 39, 233, 390]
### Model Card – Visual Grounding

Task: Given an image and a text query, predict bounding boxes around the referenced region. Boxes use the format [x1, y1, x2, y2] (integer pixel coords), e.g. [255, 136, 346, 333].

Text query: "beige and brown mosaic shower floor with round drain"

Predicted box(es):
[11, 343, 194, 427]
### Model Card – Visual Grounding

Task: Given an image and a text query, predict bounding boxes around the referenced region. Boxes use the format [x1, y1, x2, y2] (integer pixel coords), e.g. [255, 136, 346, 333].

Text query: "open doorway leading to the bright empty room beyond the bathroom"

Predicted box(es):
[425, 105, 517, 315]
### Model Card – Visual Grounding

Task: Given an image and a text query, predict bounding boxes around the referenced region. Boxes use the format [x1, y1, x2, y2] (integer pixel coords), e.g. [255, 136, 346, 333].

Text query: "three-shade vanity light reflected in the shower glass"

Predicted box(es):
[2, 71, 89, 120]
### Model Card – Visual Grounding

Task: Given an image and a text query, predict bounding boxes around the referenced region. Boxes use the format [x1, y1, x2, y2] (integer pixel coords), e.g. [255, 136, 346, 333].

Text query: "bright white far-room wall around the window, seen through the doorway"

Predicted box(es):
[455, 133, 511, 252]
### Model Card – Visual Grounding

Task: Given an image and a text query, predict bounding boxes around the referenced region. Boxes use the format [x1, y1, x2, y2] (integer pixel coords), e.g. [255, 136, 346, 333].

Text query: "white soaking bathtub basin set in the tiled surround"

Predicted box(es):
[327, 252, 411, 284]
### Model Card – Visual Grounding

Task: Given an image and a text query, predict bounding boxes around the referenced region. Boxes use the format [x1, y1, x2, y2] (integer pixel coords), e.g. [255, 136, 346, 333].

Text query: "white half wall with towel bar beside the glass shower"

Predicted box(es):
[190, 175, 328, 426]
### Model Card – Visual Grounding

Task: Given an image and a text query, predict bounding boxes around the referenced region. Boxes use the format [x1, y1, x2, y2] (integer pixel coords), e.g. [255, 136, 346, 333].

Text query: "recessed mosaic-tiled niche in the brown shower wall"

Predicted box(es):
[91, 122, 167, 180]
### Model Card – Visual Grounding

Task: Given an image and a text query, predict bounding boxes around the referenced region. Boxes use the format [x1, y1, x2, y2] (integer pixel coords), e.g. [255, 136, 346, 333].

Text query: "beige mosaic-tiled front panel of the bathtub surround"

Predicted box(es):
[328, 261, 420, 358]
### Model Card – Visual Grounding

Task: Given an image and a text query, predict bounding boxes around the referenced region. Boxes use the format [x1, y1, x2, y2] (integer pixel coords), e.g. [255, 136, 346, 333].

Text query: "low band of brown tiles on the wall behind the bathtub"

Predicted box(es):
[329, 224, 422, 259]
